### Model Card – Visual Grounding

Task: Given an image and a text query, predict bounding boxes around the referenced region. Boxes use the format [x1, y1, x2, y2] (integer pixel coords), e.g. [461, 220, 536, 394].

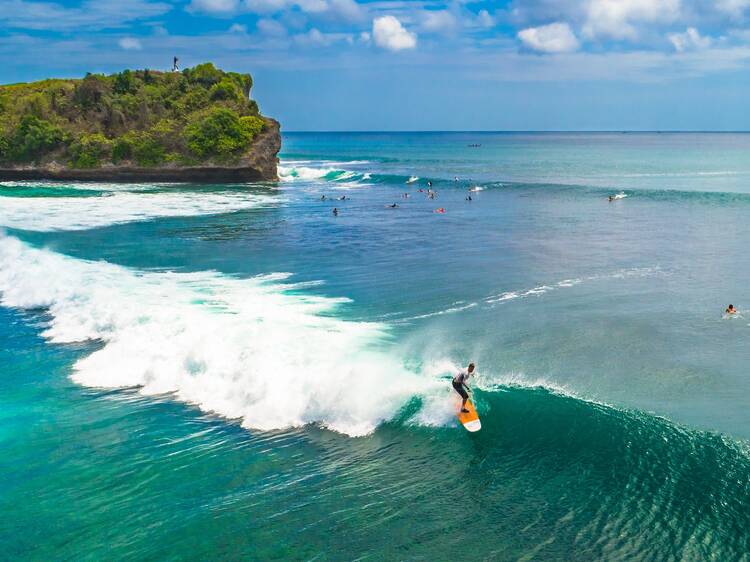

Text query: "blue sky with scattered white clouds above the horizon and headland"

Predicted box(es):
[0, 0, 750, 131]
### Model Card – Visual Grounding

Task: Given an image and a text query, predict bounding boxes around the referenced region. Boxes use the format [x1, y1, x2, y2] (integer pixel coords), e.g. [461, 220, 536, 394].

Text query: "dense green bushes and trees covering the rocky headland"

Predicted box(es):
[0, 63, 266, 169]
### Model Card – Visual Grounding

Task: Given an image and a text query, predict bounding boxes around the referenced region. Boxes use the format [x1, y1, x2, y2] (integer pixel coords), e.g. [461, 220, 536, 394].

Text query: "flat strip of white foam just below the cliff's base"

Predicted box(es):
[0, 191, 280, 231]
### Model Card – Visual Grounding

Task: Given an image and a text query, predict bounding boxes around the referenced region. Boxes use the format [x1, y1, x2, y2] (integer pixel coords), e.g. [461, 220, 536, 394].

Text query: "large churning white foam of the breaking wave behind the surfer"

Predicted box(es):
[0, 236, 450, 436]
